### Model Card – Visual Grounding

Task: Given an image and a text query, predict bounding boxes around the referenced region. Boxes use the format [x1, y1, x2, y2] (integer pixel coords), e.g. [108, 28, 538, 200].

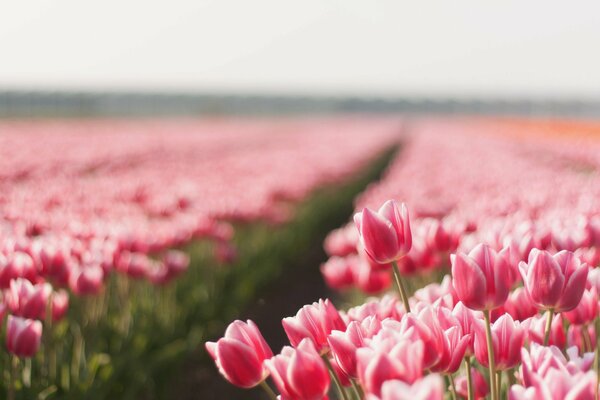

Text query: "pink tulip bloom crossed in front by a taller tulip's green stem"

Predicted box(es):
[475, 314, 525, 371]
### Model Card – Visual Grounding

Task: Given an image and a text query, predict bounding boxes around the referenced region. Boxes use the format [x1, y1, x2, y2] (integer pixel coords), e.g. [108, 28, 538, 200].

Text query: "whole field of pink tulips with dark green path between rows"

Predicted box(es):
[0, 116, 600, 400]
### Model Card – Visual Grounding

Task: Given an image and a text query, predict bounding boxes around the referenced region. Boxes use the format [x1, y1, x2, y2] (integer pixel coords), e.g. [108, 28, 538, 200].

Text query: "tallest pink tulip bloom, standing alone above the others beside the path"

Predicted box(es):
[354, 200, 412, 264]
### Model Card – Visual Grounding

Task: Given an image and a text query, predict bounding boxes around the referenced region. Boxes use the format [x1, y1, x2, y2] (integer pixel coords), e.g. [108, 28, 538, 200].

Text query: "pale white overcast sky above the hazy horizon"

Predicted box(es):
[0, 0, 600, 98]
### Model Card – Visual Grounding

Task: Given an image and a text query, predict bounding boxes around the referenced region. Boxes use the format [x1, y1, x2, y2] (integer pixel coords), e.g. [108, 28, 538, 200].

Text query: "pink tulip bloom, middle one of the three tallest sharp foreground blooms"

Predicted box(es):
[451, 244, 510, 310]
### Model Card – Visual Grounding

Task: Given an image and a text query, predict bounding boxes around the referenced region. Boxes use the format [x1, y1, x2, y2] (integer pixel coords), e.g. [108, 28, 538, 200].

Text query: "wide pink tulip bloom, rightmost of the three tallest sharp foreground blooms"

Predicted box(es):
[519, 249, 588, 312]
